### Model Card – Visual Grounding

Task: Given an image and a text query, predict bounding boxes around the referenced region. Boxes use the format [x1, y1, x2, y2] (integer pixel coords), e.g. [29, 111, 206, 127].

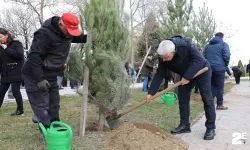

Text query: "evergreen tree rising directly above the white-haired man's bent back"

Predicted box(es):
[160, 0, 193, 39]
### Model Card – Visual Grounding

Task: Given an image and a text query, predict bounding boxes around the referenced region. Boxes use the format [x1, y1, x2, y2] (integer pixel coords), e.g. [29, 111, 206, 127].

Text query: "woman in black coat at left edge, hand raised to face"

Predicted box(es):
[0, 28, 24, 116]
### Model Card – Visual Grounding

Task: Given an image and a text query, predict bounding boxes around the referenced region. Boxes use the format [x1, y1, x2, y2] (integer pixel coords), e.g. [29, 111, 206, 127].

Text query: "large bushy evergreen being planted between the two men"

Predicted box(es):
[80, 0, 131, 130]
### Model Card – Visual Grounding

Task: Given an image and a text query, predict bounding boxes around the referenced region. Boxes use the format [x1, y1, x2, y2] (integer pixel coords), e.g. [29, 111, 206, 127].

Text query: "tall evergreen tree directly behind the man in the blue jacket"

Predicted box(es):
[192, 3, 216, 49]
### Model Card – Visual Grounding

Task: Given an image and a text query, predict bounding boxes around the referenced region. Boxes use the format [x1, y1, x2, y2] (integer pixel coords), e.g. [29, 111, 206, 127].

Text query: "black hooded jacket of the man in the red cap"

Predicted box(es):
[22, 16, 87, 82]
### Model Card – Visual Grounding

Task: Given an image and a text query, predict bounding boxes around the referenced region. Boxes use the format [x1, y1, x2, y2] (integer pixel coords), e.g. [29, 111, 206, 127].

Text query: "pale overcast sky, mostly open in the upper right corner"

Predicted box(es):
[0, 0, 250, 65]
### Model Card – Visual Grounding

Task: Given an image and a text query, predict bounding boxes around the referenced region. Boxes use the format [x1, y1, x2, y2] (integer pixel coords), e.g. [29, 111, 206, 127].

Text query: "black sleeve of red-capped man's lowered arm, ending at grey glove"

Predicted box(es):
[28, 30, 50, 82]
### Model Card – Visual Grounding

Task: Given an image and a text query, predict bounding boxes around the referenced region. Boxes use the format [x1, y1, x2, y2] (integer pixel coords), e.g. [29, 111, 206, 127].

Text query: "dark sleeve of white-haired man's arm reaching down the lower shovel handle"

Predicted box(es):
[148, 57, 167, 95]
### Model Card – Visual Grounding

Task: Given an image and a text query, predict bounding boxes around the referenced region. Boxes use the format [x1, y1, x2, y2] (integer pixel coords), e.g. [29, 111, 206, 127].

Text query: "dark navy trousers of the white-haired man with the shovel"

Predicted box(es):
[178, 69, 216, 129]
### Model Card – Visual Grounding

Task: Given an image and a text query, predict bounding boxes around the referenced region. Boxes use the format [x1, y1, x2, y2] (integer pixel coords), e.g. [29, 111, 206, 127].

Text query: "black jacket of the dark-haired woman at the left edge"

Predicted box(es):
[0, 40, 24, 83]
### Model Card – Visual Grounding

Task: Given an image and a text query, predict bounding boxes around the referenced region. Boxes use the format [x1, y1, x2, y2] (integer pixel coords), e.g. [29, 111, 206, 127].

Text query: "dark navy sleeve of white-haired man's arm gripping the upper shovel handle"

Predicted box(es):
[183, 44, 205, 80]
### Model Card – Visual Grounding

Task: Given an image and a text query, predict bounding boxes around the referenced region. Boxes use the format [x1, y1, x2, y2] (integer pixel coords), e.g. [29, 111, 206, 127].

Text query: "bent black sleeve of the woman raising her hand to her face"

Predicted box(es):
[5, 42, 24, 59]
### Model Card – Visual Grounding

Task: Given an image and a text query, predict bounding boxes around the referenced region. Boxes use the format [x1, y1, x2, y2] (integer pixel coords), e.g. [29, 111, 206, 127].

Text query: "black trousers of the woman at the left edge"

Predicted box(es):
[0, 81, 23, 111]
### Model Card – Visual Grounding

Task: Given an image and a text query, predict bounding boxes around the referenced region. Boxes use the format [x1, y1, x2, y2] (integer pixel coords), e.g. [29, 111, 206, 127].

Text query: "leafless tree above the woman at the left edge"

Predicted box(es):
[0, 7, 36, 49]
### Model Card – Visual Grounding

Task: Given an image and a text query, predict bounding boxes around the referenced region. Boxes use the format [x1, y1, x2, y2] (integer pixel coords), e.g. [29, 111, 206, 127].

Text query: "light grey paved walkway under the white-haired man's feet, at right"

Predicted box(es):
[180, 82, 250, 150]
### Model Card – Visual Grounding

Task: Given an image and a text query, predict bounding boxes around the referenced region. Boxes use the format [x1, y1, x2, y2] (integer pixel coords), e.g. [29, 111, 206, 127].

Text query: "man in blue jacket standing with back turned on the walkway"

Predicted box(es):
[203, 32, 231, 110]
